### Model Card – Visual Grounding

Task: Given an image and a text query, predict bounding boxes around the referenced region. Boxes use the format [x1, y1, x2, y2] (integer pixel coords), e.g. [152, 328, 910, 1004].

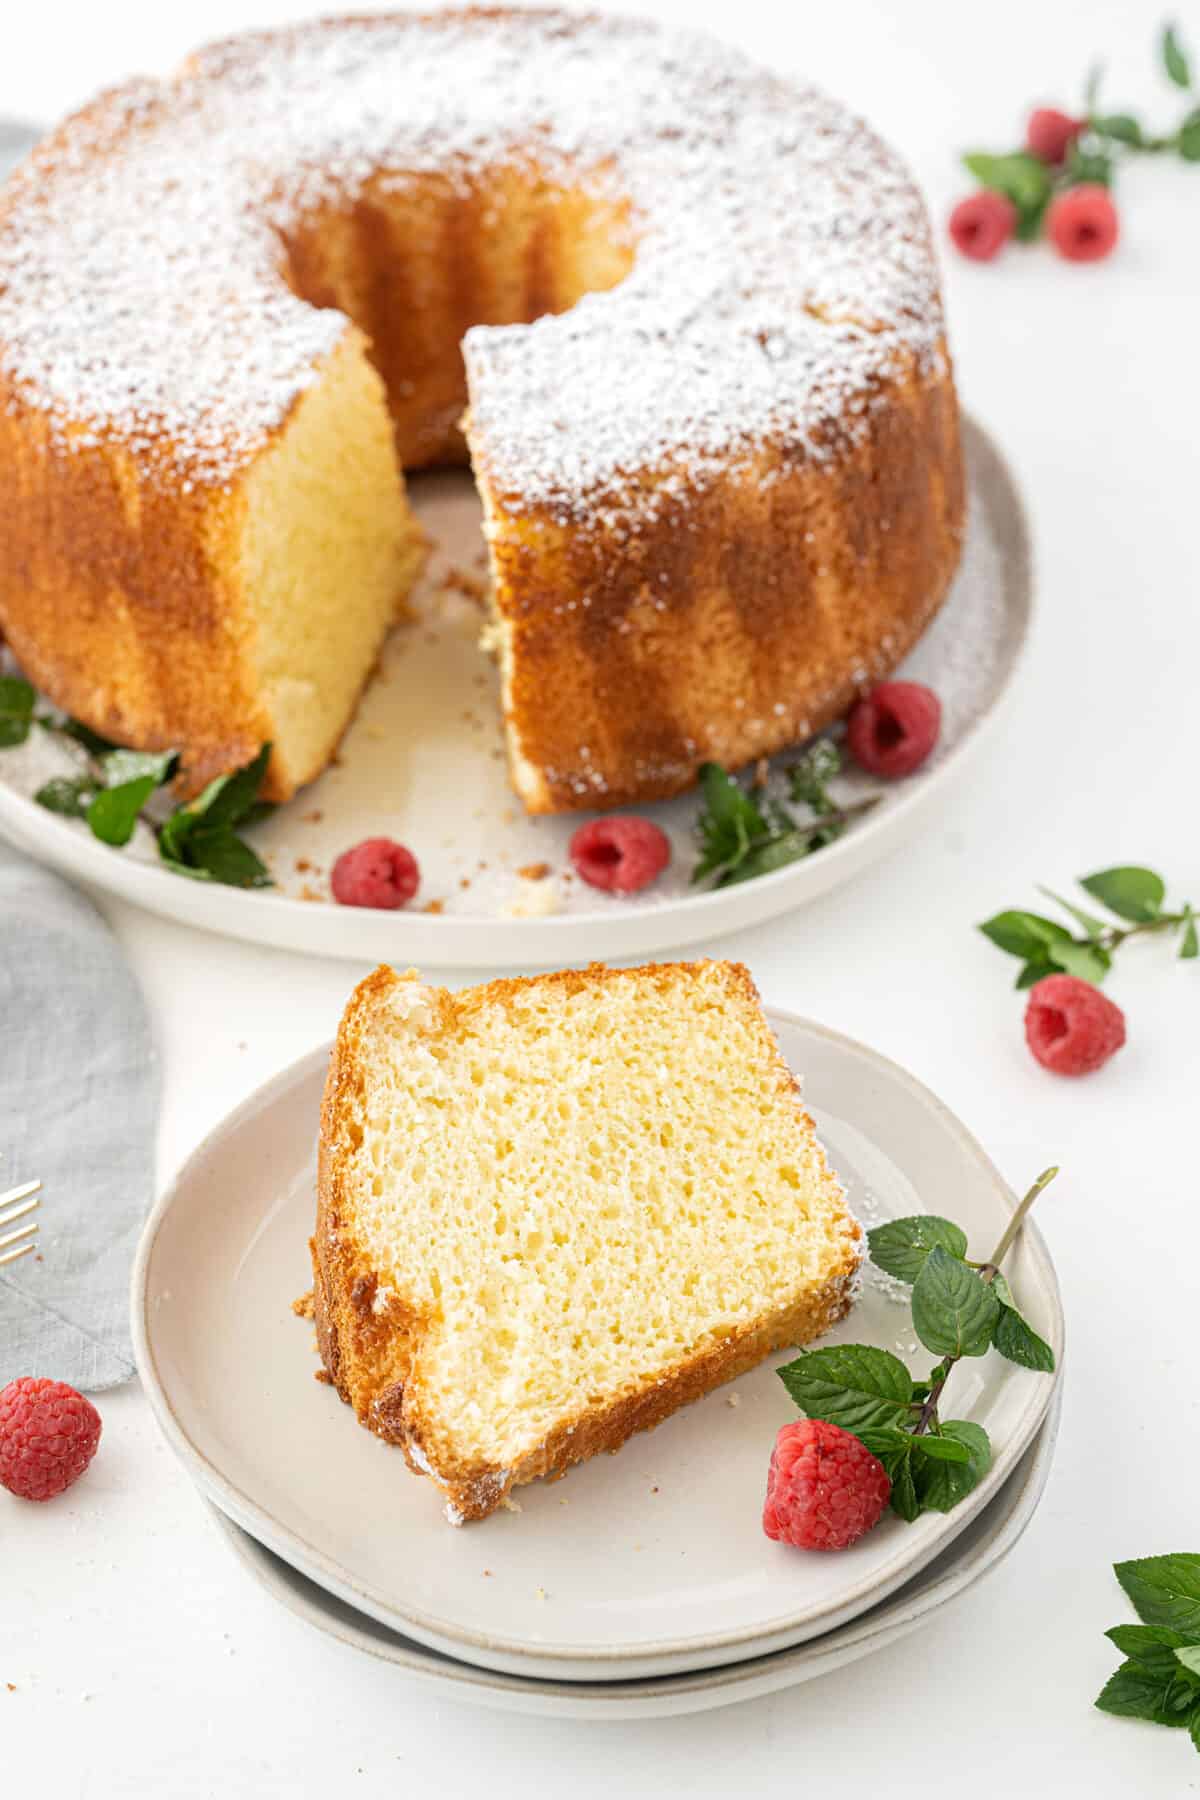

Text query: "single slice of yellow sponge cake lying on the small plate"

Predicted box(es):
[313, 961, 862, 1523]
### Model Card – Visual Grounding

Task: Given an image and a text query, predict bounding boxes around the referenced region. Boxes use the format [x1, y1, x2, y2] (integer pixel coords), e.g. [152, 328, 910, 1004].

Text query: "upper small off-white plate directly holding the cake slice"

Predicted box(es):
[133, 1013, 1063, 1681]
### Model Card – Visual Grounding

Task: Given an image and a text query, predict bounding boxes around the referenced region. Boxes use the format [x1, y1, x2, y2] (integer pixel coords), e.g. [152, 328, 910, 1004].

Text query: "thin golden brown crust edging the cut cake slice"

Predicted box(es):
[311, 963, 860, 1523]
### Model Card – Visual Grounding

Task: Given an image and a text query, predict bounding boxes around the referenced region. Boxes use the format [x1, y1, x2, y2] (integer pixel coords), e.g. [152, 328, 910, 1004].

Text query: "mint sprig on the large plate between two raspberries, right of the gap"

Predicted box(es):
[691, 738, 878, 887]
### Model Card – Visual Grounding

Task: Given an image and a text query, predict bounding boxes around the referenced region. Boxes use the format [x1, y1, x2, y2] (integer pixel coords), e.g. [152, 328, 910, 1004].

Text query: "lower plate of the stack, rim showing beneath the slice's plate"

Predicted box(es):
[210, 1393, 1061, 1719]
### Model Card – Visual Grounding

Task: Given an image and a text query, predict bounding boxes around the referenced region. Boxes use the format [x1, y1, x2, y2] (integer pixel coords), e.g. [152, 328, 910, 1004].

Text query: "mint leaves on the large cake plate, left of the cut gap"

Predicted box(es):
[0, 675, 272, 887]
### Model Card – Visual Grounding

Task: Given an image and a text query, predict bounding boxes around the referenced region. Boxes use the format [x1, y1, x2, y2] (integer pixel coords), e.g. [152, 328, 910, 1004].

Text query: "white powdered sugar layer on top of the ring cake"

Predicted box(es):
[0, 13, 943, 500]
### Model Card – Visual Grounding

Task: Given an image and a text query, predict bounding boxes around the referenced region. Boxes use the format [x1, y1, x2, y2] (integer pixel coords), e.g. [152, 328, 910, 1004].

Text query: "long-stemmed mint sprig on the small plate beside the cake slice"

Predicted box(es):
[775, 1168, 1058, 1521]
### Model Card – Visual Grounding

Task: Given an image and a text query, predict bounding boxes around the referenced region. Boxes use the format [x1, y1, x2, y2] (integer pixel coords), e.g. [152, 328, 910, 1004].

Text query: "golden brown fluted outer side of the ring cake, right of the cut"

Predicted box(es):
[491, 367, 966, 812]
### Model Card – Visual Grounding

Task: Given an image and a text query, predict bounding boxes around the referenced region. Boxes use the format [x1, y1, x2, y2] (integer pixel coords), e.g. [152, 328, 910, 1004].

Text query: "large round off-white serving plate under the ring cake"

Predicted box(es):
[0, 421, 1031, 968]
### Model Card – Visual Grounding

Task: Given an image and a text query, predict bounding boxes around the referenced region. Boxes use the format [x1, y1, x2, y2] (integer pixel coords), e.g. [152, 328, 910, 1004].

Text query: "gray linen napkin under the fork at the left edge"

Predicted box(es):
[0, 842, 158, 1391]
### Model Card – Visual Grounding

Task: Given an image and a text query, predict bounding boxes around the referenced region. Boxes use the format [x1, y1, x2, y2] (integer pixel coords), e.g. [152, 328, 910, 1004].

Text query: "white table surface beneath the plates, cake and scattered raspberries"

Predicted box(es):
[0, 0, 1200, 1800]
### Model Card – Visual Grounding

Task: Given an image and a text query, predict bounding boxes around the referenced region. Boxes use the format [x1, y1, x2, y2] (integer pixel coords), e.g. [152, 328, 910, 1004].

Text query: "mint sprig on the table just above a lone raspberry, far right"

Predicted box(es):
[979, 864, 1200, 988]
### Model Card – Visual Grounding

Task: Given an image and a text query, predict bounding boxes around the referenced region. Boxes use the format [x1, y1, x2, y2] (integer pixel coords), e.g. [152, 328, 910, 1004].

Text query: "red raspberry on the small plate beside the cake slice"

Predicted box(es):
[763, 1418, 892, 1550]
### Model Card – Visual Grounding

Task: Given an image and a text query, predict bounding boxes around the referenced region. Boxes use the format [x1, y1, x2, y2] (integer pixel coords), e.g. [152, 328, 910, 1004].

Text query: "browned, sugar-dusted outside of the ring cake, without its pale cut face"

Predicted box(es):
[0, 9, 964, 812]
